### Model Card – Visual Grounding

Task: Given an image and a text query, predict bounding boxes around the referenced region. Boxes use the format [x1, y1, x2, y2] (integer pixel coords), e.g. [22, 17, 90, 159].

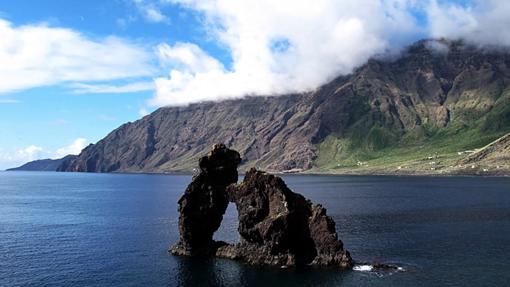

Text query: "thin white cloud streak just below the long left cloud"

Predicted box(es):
[71, 82, 154, 94]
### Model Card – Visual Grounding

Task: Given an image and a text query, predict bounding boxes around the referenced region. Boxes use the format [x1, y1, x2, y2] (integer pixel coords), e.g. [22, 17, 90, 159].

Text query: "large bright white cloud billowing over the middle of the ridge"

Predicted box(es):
[151, 0, 419, 106]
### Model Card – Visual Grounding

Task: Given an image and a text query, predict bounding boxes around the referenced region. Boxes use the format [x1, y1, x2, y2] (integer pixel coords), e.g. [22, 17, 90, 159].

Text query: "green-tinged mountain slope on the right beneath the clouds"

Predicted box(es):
[315, 42, 510, 174]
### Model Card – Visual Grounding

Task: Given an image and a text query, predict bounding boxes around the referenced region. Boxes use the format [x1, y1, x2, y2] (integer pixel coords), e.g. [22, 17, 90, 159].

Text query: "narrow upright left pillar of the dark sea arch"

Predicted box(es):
[171, 144, 241, 255]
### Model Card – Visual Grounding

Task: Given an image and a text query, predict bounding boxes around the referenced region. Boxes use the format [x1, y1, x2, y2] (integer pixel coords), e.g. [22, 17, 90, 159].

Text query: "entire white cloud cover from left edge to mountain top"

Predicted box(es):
[0, 0, 510, 107]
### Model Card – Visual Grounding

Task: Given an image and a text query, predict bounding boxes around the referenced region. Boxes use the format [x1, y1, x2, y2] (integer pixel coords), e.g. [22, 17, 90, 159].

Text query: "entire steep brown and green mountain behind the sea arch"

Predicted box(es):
[59, 41, 510, 172]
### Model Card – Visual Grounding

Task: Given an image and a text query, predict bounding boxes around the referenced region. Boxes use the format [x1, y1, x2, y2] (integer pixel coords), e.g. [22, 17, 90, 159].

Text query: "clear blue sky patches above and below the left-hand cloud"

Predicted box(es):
[0, 0, 228, 169]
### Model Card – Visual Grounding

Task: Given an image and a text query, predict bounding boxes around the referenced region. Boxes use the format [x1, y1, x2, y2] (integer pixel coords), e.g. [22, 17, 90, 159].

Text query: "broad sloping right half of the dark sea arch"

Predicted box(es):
[221, 169, 352, 267]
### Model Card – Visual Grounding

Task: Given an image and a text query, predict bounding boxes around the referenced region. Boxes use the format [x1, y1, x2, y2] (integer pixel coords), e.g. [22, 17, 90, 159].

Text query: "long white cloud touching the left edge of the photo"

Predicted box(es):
[0, 19, 154, 93]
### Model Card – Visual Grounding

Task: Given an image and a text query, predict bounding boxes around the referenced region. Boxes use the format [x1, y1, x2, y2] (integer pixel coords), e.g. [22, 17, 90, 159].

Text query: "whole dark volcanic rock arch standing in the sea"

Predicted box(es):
[170, 145, 353, 268]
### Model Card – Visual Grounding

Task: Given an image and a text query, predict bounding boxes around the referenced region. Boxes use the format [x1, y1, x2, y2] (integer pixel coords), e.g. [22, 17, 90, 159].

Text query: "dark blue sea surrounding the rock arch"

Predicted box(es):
[0, 172, 510, 286]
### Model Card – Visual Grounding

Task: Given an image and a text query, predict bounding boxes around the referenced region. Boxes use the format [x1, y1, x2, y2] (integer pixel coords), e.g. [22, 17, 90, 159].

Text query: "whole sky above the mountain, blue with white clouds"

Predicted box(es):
[0, 0, 510, 169]
